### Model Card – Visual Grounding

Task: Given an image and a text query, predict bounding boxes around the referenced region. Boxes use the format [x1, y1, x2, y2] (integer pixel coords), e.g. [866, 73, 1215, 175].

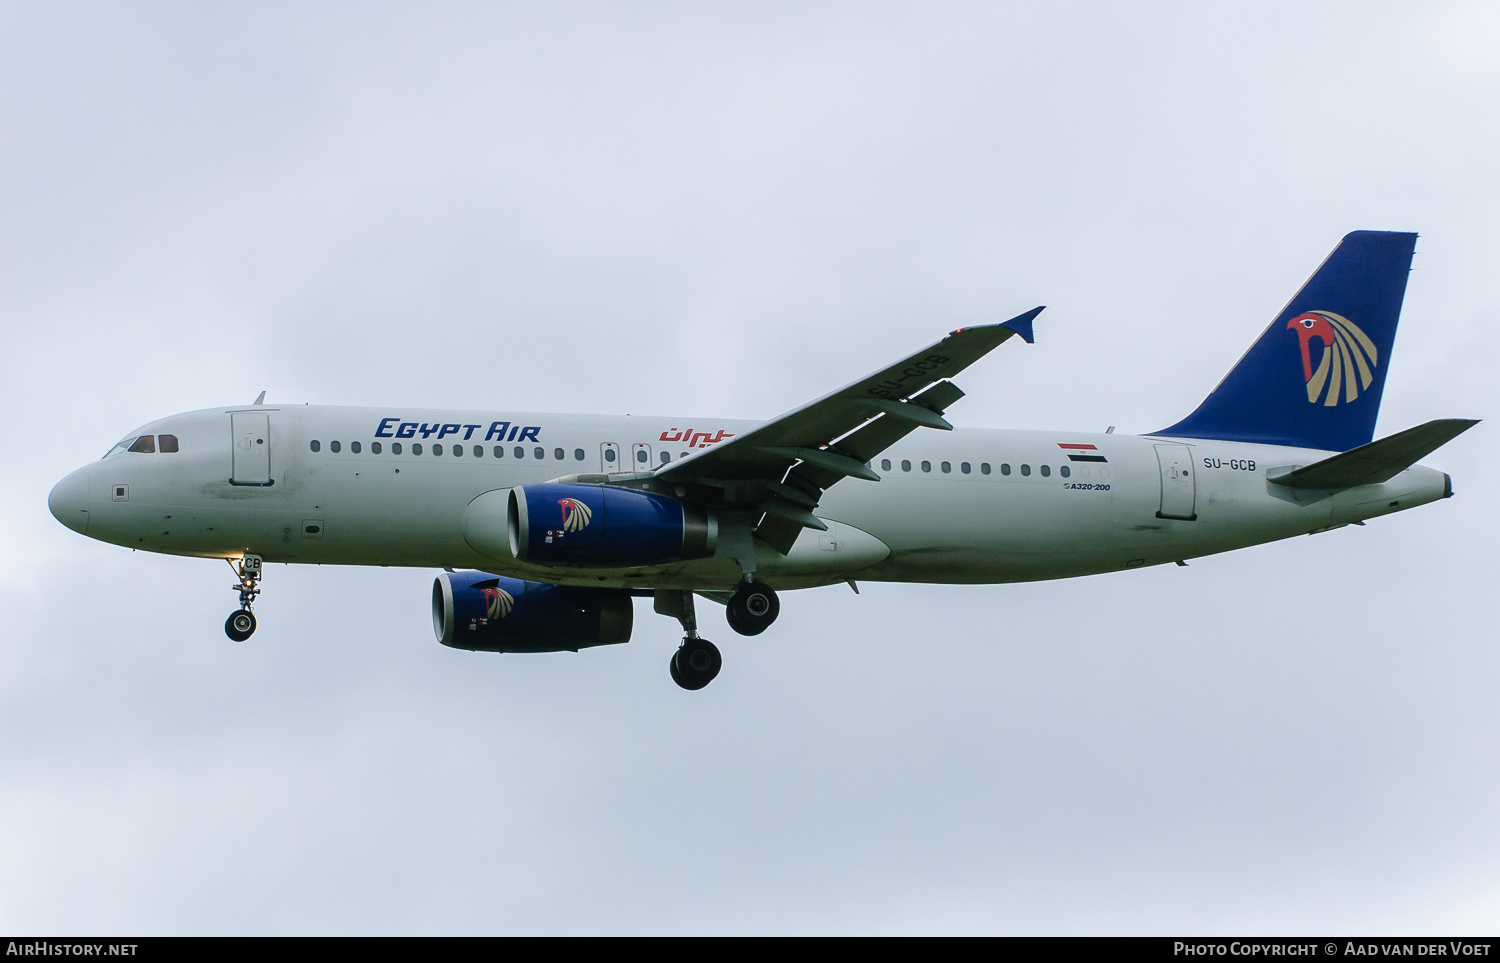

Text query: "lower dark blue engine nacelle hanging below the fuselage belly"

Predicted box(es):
[432, 572, 635, 653]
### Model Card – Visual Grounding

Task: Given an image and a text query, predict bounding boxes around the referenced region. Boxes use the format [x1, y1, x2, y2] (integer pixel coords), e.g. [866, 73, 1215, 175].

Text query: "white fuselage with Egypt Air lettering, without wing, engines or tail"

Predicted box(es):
[53, 407, 1449, 590]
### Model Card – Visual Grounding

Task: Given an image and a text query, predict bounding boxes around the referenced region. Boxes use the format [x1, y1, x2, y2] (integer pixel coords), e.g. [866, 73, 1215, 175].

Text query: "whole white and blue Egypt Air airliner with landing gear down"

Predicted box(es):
[48, 231, 1476, 689]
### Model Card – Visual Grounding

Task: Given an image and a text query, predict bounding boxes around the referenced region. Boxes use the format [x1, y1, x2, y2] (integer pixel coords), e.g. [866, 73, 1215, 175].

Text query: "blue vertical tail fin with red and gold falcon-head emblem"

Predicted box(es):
[1152, 231, 1416, 452]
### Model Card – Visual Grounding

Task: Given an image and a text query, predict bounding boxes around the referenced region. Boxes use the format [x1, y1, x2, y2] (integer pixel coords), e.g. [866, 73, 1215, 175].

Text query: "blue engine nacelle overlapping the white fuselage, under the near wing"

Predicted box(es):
[506, 483, 719, 569]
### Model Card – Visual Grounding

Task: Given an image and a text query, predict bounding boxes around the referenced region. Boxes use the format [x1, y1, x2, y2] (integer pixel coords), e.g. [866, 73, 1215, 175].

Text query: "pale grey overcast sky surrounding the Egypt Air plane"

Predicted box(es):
[0, 2, 1500, 935]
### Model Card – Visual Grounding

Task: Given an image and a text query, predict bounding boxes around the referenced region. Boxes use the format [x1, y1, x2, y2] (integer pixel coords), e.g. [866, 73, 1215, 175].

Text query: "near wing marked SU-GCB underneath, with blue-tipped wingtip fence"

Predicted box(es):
[654, 308, 1043, 554]
